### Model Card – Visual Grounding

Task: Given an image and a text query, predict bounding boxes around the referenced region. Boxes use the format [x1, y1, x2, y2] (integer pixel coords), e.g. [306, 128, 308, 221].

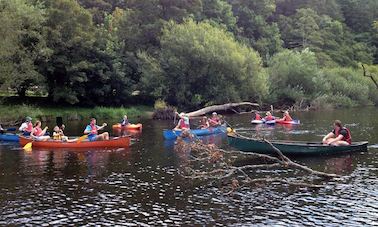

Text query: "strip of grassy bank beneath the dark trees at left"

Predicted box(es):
[0, 105, 153, 124]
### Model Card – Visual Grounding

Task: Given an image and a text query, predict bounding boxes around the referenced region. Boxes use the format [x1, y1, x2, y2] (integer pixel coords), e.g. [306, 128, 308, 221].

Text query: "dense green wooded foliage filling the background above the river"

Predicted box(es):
[0, 0, 378, 109]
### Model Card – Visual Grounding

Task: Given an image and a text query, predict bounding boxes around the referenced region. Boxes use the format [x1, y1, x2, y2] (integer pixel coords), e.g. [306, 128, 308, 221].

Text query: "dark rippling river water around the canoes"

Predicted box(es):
[0, 108, 378, 226]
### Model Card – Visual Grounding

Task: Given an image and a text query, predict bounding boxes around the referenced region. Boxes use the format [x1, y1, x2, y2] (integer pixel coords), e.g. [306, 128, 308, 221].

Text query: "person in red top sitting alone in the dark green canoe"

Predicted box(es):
[323, 120, 352, 146]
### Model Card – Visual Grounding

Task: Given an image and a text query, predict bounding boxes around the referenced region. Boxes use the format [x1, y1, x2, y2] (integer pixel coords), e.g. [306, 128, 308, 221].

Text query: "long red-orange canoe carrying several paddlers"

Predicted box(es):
[20, 136, 131, 148]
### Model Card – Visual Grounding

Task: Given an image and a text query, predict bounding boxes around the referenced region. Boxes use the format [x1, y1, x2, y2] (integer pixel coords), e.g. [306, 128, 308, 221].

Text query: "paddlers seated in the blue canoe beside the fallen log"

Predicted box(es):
[173, 112, 222, 130]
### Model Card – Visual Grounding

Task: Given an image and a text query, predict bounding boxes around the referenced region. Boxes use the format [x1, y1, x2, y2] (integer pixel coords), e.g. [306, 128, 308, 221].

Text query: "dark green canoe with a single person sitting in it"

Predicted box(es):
[228, 135, 368, 155]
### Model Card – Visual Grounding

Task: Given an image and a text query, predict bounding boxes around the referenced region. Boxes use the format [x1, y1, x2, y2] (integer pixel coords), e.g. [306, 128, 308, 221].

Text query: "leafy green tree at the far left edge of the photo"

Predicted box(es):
[0, 0, 50, 96]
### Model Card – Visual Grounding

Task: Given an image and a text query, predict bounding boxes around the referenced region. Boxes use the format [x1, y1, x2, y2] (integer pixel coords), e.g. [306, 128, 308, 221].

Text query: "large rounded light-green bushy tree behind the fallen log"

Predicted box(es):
[141, 20, 267, 108]
